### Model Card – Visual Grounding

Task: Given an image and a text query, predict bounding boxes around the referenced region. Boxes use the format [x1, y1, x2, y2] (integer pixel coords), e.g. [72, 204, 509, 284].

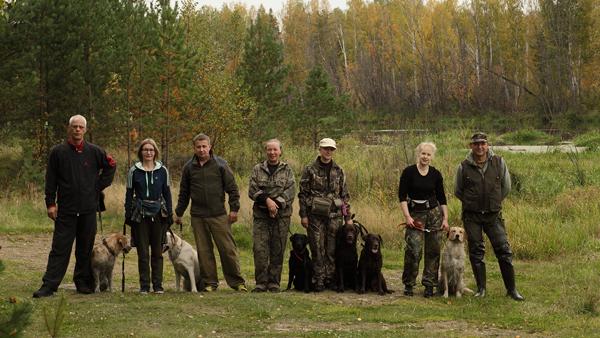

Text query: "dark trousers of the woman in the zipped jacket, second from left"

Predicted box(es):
[132, 217, 167, 291]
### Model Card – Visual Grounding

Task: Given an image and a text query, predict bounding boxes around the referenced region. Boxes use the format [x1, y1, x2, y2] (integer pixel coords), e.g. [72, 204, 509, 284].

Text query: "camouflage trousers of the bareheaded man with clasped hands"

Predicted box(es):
[252, 216, 290, 288]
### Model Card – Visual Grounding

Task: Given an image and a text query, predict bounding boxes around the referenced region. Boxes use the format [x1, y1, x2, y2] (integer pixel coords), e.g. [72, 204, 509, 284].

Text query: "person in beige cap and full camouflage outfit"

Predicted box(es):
[298, 138, 352, 292]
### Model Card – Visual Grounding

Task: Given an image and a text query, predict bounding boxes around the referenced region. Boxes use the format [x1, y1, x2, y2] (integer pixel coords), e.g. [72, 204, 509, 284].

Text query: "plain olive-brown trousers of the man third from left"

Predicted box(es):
[192, 214, 246, 289]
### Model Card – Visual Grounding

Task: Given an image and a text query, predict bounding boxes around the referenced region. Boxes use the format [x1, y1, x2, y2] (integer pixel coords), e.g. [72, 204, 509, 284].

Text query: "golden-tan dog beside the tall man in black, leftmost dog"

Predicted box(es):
[92, 233, 131, 292]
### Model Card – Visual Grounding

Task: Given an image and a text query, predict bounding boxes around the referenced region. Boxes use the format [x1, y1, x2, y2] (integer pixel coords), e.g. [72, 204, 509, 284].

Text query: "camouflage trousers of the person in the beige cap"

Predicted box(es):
[306, 215, 344, 286]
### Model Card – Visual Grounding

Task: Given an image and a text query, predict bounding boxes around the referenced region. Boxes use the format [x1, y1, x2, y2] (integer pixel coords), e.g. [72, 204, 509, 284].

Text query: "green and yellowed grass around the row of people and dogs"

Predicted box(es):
[0, 131, 600, 337]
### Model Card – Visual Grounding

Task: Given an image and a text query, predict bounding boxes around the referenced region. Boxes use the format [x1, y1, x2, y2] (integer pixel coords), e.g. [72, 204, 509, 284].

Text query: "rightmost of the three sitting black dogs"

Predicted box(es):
[358, 234, 394, 295]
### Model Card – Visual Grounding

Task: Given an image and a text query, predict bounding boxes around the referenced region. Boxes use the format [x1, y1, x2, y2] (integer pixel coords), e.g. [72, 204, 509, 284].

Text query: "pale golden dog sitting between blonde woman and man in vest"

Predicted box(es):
[438, 227, 473, 298]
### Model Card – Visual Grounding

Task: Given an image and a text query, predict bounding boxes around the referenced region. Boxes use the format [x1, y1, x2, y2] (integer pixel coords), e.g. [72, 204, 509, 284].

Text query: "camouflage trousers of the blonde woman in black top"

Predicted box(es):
[402, 207, 443, 287]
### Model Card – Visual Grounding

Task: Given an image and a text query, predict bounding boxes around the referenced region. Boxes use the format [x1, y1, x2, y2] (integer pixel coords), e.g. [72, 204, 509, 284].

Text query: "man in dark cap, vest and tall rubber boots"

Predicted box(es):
[454, 132, 525, 301]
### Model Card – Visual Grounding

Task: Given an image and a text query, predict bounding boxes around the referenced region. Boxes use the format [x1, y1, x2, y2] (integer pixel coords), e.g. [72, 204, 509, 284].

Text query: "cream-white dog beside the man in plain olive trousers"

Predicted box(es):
[166, 231, 204, 292]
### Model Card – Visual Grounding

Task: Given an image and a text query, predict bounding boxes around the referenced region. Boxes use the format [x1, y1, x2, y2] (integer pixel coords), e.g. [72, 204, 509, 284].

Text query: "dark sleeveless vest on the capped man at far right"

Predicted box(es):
[461, 155, 502, 212]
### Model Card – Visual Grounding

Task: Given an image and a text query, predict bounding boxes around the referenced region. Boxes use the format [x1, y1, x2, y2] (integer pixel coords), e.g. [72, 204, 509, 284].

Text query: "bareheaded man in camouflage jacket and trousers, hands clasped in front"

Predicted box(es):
[248, 139, 296, 292]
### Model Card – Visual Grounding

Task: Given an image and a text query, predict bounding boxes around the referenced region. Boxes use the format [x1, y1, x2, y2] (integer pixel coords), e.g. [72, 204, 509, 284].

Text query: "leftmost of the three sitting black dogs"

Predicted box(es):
[287, 234, 314, 292]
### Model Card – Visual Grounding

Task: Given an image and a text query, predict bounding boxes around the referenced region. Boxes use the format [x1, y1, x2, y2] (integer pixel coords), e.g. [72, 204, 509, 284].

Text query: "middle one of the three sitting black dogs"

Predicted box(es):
[335, 224, 359, 292]
